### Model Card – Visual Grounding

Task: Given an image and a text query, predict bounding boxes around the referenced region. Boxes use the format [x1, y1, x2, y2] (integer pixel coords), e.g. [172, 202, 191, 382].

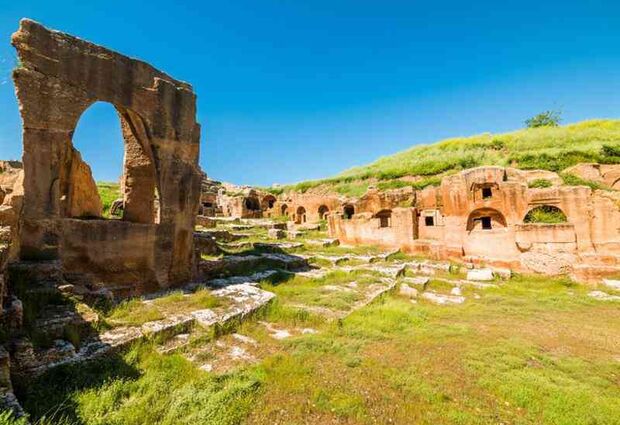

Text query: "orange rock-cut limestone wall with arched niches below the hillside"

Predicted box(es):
[329, 166, 620, 279]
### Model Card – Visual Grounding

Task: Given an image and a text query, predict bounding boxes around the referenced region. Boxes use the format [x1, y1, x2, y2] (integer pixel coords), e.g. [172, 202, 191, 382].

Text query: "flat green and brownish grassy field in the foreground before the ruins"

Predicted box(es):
[7, 274, 620, 425]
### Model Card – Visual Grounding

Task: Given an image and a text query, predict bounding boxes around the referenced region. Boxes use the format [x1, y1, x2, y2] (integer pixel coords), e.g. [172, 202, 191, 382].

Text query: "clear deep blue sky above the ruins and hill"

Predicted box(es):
[0, 0, 620, 185]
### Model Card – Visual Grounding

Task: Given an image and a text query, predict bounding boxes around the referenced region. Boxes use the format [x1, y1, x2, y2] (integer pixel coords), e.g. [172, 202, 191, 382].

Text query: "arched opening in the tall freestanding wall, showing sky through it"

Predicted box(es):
[70, 102, 160, 223]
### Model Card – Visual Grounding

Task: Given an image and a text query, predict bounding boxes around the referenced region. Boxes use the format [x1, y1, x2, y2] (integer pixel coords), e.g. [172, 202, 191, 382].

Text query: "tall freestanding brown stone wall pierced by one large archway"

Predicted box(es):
[12, 20, 201, 292]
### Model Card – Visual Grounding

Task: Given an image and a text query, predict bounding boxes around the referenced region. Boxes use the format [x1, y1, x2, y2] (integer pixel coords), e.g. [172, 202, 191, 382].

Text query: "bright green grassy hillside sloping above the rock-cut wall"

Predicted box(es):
[279, 120, 620, 196]
